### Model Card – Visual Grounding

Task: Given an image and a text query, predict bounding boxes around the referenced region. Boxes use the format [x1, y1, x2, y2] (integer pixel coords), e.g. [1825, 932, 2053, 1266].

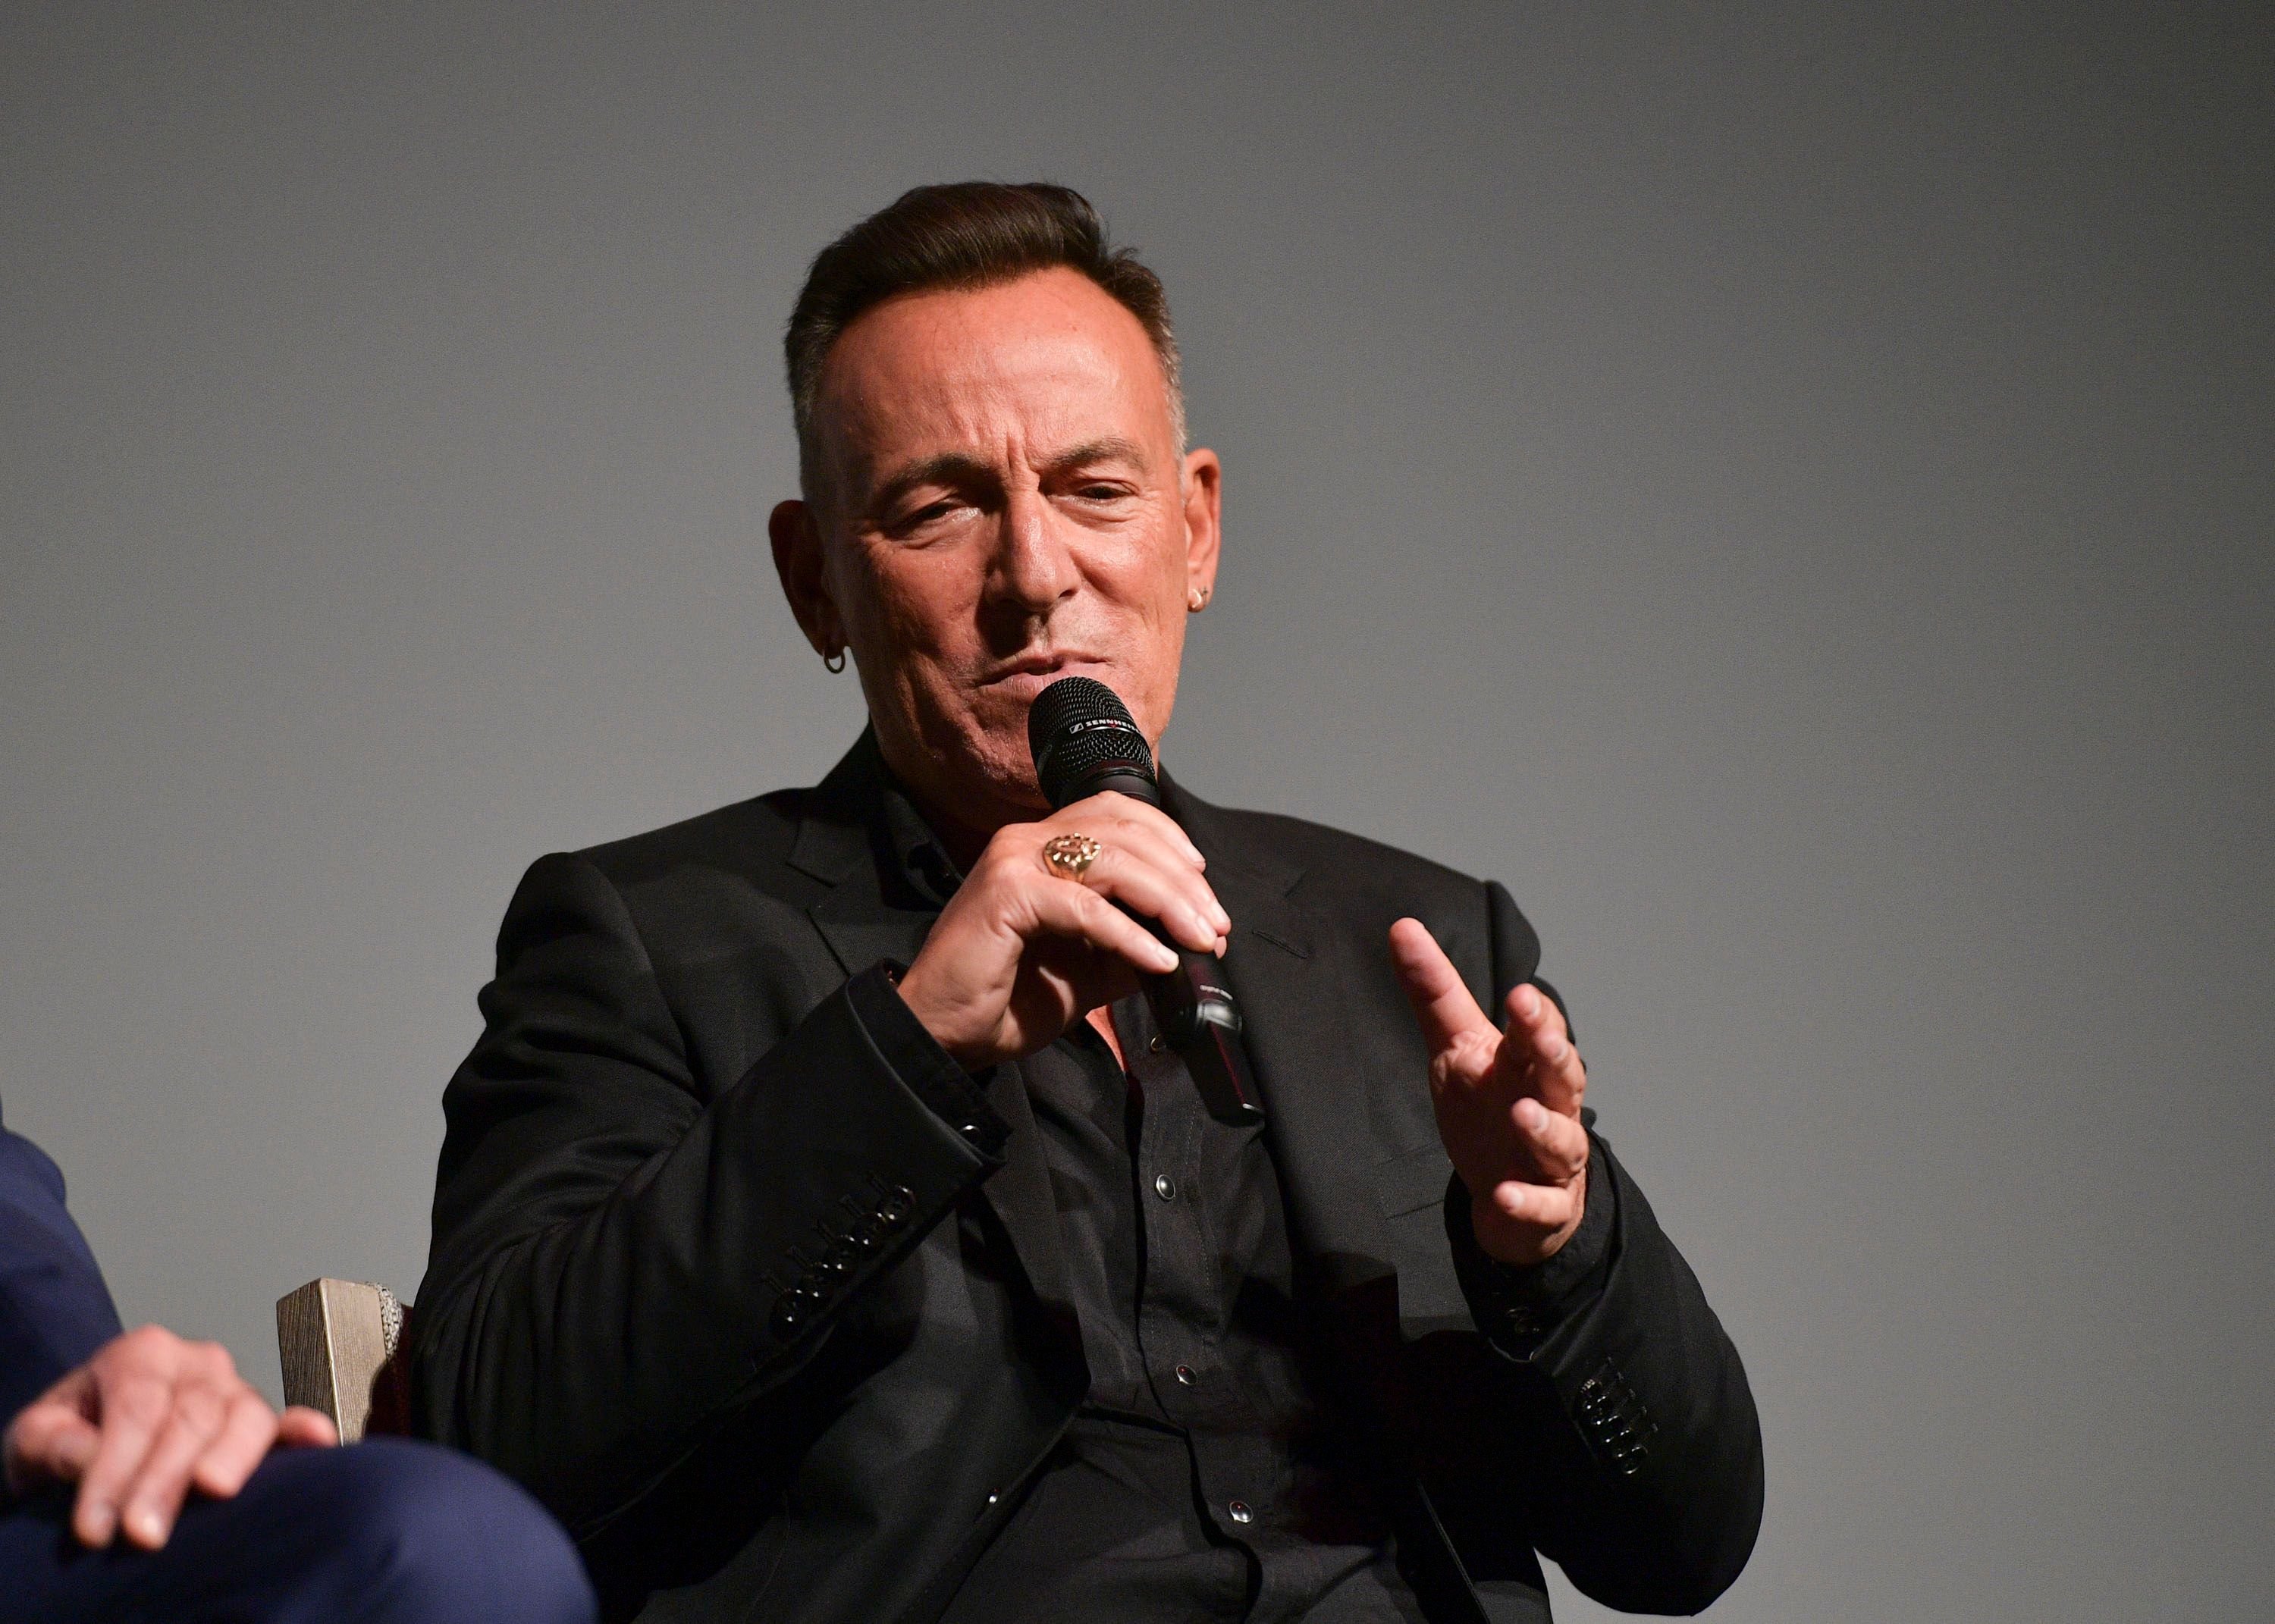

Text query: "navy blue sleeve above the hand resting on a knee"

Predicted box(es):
[0, 1128, 118, 1428]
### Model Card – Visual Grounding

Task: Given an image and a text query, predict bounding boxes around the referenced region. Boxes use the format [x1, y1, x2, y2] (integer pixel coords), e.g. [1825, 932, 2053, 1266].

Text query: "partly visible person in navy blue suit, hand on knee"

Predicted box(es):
[0, 1096, 594, 1624]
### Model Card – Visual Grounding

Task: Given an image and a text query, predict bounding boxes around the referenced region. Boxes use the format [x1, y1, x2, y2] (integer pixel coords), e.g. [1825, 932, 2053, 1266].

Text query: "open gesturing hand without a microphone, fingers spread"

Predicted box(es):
[1390, 919, 1588, 1265]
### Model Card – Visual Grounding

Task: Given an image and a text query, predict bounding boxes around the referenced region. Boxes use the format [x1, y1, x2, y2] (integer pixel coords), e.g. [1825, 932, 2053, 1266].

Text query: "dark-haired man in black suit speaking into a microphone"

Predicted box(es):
[414, 184, 1761, 1624]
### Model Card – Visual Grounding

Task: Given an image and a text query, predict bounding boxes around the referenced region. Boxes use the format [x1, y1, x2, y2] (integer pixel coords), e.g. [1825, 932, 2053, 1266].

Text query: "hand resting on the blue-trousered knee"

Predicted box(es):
[0, 1326, 339, 1551]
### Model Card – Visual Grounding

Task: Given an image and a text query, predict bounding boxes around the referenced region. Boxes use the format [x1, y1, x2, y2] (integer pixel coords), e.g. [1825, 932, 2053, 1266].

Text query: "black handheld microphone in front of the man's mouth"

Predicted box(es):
[1026, 678, 1265, 1128]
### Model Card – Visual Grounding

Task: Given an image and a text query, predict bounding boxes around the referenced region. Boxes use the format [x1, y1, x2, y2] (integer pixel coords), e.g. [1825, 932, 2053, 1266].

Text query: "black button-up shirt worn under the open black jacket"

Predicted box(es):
[864, 789, 1602, 1624]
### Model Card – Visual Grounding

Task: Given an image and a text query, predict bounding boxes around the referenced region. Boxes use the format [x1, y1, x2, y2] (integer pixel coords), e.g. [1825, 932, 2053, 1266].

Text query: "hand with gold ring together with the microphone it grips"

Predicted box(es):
[901, 678, 1263, 1124]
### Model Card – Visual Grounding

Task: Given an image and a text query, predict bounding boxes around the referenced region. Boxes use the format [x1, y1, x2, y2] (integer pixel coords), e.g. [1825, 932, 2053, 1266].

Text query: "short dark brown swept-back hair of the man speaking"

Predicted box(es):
[783, 180, 1185, 496]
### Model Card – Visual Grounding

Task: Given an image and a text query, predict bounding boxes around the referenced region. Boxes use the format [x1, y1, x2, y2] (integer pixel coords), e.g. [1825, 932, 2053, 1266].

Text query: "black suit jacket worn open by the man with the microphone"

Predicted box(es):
[412, 737, 1761, 1624]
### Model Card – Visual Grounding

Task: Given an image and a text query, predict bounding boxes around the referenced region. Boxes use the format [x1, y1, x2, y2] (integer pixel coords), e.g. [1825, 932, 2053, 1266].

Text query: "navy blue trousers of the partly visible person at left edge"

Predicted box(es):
[0, 1437, 596, 1624]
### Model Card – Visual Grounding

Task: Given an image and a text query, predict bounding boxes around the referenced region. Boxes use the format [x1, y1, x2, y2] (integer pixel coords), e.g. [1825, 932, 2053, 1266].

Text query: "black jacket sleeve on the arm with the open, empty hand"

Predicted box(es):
[1420, 885, 1763, 1613]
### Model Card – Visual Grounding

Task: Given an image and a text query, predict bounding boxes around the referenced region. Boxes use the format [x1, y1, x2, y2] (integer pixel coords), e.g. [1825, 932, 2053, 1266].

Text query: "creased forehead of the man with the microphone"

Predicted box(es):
[814, 271, 1174, 503]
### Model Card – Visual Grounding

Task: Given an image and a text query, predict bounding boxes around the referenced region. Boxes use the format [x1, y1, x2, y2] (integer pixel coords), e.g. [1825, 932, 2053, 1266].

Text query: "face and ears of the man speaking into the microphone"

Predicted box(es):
[774, 271, 1219, 835]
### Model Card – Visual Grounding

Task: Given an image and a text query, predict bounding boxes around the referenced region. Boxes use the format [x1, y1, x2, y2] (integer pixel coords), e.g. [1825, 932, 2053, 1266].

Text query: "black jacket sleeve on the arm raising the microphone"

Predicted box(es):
[412, 857, 1003, 1533]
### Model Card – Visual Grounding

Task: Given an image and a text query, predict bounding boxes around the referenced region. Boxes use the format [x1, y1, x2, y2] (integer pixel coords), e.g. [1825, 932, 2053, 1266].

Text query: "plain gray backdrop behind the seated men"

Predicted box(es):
[0, 5, 2275, 1624]
